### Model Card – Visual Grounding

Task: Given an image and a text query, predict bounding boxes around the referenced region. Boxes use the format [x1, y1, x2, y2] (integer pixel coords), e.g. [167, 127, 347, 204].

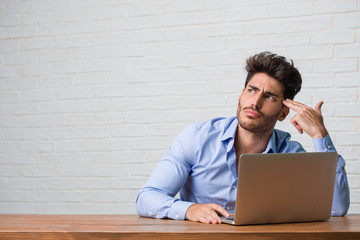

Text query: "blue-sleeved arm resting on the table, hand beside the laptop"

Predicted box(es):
[136, 125, 229, 223]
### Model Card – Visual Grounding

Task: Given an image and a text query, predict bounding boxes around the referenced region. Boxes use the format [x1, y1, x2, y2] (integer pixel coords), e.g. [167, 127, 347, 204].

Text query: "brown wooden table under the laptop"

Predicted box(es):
[0, 215, 360, 240]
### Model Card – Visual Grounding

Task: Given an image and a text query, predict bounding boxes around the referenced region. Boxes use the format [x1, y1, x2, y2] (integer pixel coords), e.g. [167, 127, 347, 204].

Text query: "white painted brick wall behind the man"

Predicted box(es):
[0, 0, 360, 214]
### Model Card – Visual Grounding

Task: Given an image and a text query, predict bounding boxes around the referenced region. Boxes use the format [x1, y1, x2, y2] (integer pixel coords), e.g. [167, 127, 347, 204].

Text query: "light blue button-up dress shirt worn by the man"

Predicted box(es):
[136, 117, 350, 219]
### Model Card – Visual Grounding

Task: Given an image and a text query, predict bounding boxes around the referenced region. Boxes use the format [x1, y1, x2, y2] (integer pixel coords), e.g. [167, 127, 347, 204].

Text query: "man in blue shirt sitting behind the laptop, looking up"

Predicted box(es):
[136, 52, 350, 224]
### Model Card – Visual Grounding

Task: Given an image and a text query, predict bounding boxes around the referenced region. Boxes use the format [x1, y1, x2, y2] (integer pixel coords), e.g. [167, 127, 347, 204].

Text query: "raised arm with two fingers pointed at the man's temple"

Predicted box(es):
[283, 99, 350, 216]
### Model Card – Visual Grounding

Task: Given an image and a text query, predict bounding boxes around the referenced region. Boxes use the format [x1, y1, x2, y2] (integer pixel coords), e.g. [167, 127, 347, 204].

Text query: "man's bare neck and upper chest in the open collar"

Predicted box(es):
[234, 124, 272, 158]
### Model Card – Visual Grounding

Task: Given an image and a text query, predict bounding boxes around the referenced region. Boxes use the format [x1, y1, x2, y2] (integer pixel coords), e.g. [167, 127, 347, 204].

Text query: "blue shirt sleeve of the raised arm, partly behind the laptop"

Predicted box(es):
[313, 135, 350, 216]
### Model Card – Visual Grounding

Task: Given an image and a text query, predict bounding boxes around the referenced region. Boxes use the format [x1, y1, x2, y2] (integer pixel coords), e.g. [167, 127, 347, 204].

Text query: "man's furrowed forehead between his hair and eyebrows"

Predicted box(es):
[247, 73, 284, 96]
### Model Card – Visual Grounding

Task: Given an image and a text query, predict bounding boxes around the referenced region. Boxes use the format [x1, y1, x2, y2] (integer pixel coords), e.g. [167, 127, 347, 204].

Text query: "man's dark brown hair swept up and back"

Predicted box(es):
[245, 52, 302, 99]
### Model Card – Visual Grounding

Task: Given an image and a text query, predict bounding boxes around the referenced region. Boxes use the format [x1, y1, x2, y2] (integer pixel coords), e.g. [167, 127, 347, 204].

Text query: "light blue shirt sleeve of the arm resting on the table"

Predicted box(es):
[136, 124, 197, 220]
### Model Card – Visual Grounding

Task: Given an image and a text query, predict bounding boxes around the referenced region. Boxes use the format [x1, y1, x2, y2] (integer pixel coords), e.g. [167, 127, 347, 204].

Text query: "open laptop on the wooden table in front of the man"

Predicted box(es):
[222, 152, 338, 225]
